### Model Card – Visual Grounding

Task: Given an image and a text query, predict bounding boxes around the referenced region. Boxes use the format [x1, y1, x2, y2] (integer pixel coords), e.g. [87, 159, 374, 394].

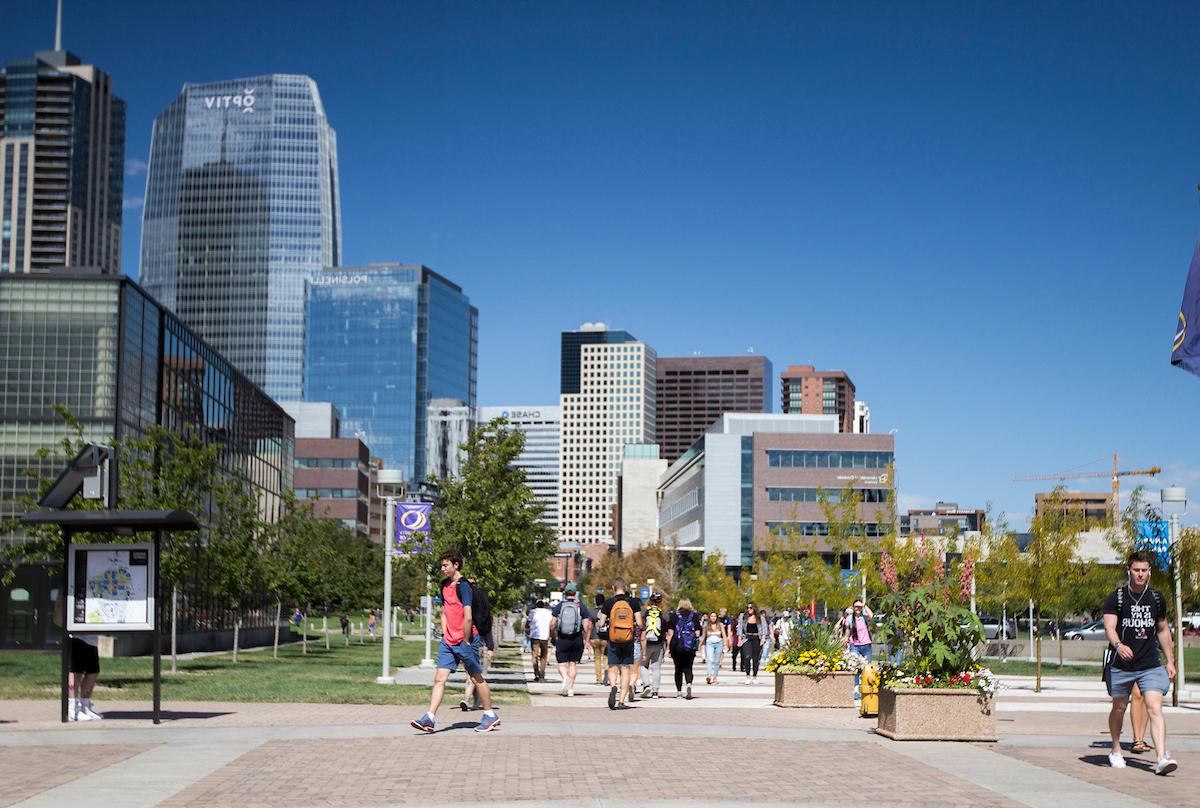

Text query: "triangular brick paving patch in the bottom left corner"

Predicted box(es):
[0, 743, 154, 808]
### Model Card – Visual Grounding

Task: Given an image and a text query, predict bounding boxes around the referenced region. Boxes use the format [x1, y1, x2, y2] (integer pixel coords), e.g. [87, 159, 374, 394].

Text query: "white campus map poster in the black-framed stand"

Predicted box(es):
[67, 544, 154, 633]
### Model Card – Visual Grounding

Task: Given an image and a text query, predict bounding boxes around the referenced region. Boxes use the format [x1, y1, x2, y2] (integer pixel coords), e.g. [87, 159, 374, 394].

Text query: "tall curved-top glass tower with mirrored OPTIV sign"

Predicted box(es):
[140, 74, 342, 400]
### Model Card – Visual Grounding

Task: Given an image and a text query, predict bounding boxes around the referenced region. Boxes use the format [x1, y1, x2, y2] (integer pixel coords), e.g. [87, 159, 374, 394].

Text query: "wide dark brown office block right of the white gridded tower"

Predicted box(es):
[654, 355, 772, 463]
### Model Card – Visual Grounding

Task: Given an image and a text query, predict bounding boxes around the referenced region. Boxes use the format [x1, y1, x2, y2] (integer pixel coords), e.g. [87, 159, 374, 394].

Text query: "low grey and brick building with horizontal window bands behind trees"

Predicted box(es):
[659, 413, 895, 567]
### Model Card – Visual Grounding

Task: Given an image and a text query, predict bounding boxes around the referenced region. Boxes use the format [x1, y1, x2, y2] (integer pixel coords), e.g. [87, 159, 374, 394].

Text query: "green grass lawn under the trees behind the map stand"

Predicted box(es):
[0, 636, 529, 705]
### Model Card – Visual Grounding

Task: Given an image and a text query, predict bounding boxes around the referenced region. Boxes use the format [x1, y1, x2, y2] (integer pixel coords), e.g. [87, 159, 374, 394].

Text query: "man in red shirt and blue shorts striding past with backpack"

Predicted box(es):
[410, 550, 500, 732]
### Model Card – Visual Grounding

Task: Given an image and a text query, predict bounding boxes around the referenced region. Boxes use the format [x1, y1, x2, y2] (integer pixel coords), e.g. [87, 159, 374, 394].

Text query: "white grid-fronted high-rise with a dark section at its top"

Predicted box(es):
[558, 325, 656, 553]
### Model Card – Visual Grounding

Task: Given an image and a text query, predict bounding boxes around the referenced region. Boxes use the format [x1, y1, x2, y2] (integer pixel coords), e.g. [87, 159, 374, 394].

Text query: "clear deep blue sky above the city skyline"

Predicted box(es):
[0, 0, 1200, 523]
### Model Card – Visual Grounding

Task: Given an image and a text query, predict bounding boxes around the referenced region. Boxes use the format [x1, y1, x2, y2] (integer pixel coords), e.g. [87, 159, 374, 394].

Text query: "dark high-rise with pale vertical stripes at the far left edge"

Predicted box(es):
[0, 43, 125, 274]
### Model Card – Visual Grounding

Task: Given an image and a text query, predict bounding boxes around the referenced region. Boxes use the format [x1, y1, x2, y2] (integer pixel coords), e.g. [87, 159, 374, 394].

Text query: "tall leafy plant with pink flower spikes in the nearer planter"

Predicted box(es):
[880, 537, 996, 693]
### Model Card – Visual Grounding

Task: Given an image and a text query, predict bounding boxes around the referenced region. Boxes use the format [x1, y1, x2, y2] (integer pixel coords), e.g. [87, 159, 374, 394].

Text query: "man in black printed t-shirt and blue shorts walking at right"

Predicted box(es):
[1104, 552, 1178, 774]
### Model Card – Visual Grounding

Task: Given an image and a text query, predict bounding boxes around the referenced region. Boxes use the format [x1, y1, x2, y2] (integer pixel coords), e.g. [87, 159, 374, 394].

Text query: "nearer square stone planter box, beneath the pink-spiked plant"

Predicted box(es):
[875, 688, 996, 741]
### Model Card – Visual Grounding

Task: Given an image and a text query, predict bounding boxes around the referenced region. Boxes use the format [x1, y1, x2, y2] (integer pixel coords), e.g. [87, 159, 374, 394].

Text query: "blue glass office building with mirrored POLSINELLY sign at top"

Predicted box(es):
[304, 264, 479, 480]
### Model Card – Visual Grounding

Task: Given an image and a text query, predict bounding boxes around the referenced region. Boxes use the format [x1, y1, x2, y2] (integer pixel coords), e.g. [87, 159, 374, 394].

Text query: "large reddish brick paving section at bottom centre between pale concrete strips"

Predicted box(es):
[163, 728, 1021, 808]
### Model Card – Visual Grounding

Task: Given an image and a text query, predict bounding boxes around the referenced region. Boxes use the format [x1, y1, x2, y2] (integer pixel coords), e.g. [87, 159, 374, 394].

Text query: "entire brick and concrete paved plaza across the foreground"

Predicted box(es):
[0, 657, 1200, 808]
